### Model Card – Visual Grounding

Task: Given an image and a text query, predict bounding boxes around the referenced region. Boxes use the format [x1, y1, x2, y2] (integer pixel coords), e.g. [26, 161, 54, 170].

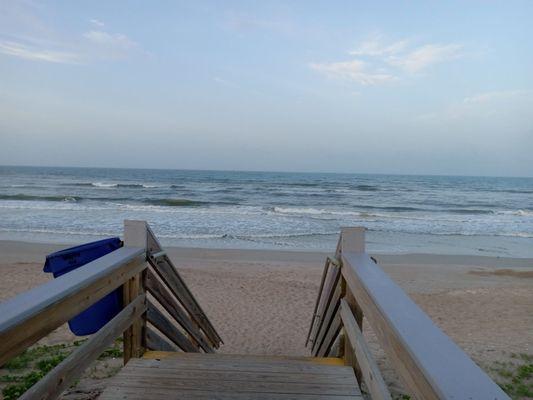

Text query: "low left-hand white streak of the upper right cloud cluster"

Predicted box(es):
[310, 60, 395, 85]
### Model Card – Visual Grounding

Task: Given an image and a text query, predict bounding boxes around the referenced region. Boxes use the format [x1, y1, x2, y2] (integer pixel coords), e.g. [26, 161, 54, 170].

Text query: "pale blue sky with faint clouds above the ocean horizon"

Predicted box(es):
[0, 0, 533, 176]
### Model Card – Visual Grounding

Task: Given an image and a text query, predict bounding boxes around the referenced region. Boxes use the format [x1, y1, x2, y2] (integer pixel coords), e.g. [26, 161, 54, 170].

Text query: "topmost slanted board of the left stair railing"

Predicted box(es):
[146, 225, 223, 348]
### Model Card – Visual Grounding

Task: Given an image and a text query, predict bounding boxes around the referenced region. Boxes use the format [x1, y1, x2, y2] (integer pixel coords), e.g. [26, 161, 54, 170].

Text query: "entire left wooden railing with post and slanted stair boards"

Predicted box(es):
[0, 221, 222, 399]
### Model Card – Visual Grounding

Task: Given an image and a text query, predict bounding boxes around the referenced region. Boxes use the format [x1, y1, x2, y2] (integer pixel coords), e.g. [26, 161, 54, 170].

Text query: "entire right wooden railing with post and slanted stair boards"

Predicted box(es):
[306, 228, 509, 400]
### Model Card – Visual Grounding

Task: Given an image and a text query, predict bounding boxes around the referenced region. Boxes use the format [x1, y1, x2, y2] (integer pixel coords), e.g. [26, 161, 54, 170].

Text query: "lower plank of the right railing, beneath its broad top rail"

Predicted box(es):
[340, 299, 391, 400]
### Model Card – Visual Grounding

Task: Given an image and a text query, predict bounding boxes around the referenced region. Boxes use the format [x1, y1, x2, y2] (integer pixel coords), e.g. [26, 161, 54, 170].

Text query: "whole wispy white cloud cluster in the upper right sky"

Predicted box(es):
[309, 36, 463, 85]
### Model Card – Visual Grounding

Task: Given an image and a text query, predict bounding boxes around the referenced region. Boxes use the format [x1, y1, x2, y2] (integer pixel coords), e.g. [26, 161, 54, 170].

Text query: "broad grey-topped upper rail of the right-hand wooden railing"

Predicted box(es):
[342, 251, 509, 400]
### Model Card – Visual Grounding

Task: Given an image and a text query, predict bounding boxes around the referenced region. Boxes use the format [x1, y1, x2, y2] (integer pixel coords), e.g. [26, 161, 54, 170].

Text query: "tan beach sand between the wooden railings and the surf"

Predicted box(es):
[0, 241, 533, 399]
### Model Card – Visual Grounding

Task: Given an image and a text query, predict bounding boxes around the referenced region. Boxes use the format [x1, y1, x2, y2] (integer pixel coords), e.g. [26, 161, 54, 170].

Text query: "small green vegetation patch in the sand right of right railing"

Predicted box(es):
[490, 353, 533, 399]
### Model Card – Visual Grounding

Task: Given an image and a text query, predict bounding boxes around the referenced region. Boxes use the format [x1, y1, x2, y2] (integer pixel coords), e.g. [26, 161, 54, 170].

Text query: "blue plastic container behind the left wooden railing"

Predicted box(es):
[43, 237, 122, 336]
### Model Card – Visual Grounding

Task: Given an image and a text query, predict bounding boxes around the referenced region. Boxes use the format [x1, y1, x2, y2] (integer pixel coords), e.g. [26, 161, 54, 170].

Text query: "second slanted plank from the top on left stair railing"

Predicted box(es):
[146, 271, 213, 353]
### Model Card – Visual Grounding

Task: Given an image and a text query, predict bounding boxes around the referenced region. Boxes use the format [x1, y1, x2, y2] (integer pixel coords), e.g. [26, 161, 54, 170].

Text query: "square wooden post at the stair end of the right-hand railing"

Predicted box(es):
[336, 227, 365, 386]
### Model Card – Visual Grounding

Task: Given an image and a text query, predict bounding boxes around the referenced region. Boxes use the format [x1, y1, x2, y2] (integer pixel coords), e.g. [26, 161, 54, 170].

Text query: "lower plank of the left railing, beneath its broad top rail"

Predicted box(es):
[20, 295, 146, 400]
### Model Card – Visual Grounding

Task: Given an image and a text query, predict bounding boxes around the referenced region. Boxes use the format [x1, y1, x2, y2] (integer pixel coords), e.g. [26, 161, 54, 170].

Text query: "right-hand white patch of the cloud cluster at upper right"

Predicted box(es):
[386, 44, 463, 73]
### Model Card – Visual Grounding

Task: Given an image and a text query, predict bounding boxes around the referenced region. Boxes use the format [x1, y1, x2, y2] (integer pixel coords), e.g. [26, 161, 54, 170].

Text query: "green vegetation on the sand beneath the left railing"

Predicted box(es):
[0, 338, 122, 400]
